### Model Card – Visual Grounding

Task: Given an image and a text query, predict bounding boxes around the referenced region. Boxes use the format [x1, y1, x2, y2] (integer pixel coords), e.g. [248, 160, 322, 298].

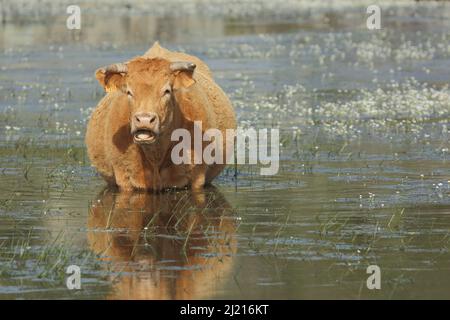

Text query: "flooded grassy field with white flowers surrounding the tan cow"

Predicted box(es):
[0, 2, 450, 299]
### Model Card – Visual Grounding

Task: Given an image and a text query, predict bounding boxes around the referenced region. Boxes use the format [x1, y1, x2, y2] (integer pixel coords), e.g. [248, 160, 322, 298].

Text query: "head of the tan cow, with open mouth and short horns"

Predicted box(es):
[95, 58, 195, 144]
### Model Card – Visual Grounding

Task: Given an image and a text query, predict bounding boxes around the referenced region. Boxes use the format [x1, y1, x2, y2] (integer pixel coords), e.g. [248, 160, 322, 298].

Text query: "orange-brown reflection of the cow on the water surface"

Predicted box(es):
[88, 188, 236, 299]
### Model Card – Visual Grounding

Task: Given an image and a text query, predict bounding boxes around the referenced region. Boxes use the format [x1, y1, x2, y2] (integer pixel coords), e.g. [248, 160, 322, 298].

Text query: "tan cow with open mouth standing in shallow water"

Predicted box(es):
[86, 43, 236, 190]
